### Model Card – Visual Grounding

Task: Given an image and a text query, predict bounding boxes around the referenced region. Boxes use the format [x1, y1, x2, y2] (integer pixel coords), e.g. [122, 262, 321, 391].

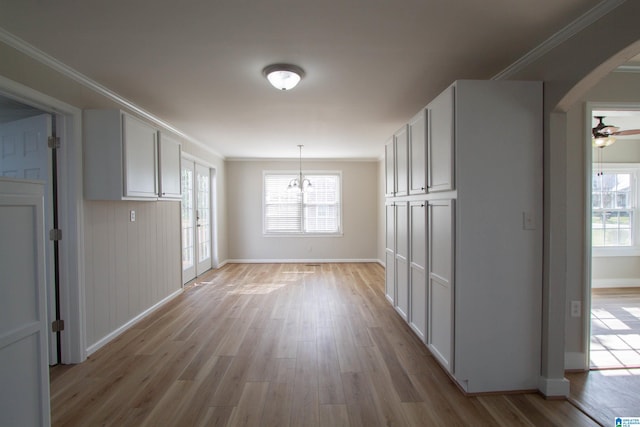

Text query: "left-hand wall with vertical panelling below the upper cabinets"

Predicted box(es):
[0, 42, 228, 358]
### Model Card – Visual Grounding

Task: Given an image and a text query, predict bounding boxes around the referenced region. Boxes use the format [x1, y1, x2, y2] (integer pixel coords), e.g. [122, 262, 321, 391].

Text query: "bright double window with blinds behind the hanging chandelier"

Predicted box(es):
[263, 172, 342, 235]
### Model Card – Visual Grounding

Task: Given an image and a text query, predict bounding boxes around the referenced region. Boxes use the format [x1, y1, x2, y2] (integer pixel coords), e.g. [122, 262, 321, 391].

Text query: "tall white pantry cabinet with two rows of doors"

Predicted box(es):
[385, 80, 543, 393]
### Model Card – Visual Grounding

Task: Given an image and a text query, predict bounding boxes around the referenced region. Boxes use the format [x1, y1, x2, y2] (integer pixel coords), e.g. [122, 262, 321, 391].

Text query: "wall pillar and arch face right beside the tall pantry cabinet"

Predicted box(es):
[501, 1, 640, 388]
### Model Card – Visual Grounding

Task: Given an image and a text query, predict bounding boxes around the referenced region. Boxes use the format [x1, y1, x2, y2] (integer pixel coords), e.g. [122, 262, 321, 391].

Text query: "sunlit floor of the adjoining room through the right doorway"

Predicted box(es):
[591, 288, 640, 369]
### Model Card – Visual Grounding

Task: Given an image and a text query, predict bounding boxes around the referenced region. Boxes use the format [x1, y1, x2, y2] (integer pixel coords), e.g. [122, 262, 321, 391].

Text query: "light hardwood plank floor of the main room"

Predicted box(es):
[51, 264, 597, 427]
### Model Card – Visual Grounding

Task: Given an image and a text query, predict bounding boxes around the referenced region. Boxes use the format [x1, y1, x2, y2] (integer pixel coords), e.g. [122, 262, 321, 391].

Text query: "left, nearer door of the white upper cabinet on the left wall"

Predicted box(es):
[122, 114, 158, 198]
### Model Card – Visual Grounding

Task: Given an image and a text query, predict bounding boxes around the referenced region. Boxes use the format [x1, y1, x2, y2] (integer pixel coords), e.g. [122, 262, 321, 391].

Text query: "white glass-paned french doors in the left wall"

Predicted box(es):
[182, 159, 212, 283]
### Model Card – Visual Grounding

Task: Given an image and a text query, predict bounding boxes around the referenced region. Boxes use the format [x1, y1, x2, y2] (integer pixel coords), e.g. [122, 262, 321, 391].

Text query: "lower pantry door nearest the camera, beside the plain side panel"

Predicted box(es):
[427, 200, 455, 373]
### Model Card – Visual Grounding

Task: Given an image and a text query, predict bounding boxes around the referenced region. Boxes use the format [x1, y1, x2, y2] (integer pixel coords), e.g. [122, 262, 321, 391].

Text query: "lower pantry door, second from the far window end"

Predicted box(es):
[396, 202, 409, 320]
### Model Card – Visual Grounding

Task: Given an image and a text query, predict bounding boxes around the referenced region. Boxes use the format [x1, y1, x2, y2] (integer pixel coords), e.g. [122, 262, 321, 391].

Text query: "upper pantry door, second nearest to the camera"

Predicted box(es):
[409, 108, 427, 194]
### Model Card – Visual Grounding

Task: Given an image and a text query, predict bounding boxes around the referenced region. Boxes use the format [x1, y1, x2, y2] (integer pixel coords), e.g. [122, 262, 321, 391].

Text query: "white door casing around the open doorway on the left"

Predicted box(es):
[0, 76, 86, 364]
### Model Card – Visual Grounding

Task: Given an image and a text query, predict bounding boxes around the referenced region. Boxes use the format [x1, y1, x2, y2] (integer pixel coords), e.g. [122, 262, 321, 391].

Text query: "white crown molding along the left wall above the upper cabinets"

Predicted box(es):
[0, 27, 225, 160]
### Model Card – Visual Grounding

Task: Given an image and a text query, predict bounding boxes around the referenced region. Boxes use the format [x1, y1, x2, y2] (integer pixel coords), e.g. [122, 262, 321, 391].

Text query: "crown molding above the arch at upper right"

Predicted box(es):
[491, 0, 626, 80]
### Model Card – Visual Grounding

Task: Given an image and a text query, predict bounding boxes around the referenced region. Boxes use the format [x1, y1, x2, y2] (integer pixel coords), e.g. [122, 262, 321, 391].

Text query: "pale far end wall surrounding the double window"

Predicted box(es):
[226, 160, 378, 261]
